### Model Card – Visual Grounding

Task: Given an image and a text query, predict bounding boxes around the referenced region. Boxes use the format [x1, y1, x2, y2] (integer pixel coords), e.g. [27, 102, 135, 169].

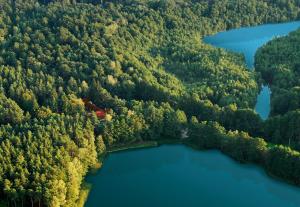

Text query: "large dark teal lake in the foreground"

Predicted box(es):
[86, 145, 300, 207]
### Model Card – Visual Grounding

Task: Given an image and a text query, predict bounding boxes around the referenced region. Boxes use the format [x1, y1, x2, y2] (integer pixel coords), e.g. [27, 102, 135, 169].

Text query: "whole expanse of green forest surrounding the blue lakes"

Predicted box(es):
[0, 0, 300, 207]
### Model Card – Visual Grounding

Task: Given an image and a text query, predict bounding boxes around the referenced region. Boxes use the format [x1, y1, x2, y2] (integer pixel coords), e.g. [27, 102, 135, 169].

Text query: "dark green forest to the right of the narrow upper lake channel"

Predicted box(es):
[256, 29, 300, 150]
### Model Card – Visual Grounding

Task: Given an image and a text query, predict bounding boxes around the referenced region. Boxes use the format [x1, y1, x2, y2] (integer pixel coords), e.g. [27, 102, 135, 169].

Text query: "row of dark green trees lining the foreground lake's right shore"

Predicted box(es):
[190, 122, 300, 185]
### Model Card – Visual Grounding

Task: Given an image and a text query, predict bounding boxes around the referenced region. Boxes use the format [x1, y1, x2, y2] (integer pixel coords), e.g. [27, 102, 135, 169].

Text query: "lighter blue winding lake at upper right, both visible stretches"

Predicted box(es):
[204, 21, 300, 120]
